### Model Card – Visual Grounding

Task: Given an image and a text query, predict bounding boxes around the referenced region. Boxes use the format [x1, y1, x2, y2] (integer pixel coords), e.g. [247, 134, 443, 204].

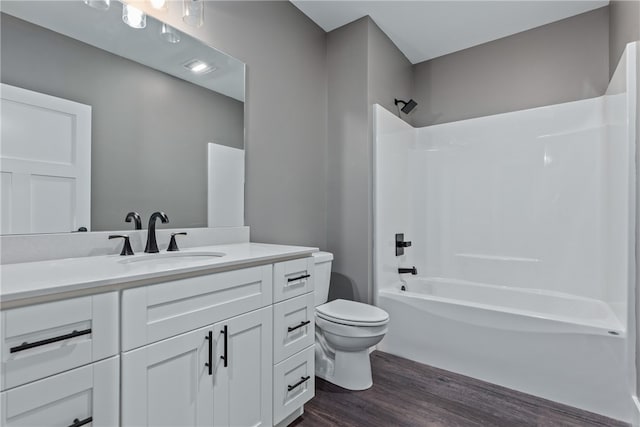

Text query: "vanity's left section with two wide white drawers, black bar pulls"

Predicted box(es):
[0, 292, 120, 427]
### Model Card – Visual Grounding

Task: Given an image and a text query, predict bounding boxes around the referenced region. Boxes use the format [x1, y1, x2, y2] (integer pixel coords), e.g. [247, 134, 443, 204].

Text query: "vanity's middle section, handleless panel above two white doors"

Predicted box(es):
[122, 265, 273, 426]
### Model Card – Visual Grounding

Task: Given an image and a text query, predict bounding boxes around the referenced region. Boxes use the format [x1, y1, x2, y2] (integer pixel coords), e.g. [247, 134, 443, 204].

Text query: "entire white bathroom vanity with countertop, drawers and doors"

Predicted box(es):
[0, 243, 316, 427]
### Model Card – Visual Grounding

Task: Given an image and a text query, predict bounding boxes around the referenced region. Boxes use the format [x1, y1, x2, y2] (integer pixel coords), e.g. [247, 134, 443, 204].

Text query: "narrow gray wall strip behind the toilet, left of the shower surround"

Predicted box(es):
[327, 18, 371, 301]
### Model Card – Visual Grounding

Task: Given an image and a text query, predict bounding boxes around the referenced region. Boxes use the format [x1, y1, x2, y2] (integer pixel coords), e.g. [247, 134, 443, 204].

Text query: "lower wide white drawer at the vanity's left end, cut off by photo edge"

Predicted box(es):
[0, 356, 120, 427]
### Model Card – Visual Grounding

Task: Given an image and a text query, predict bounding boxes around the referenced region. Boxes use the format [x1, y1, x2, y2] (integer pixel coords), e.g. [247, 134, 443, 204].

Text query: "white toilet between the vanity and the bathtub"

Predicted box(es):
[313, 252, 389, 390]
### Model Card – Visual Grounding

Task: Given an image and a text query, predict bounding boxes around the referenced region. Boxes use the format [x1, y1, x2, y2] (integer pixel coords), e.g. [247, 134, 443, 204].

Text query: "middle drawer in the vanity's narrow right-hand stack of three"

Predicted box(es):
[273, 292, 315, 363]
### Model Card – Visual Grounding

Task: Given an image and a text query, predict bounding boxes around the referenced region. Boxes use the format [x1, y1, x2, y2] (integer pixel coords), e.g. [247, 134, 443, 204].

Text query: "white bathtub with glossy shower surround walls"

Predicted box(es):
[374, 44, 638, 421]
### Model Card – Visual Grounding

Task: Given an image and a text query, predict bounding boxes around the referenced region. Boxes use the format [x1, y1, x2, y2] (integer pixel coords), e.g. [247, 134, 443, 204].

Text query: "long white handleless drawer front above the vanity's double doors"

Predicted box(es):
[122, 265, 273, 351]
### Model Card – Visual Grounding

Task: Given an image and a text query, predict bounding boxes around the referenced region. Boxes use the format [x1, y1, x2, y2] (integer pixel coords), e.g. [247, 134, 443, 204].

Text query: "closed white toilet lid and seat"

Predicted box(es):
[316, 299, 389, 326]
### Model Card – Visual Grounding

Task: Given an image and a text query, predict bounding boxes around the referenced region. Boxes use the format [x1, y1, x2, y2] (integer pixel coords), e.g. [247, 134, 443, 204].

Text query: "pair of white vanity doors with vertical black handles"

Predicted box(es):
[122, 307, 272, 426]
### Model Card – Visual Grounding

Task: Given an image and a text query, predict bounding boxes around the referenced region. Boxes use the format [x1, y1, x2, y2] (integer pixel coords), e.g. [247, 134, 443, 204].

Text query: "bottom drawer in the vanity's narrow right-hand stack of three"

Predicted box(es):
[273, 346, 315, 425]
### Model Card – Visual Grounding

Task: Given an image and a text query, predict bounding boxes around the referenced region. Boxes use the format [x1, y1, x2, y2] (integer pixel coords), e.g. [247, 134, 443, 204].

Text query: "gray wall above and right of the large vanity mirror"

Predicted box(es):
[150, 1, 327, 248]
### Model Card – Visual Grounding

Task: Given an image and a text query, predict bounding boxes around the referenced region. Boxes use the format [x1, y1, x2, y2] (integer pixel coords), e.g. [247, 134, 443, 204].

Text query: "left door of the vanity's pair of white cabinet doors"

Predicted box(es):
[121, 326, 214, 426]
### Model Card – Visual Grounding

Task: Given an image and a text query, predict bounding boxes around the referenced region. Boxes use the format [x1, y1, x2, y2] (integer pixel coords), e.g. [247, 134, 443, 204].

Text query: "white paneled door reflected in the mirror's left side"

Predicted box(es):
[0, 84, 91, 234]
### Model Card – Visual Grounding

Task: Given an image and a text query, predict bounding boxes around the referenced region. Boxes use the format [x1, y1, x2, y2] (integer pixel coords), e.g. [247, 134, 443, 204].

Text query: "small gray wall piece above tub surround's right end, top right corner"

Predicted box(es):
[609, 0, 640, 76]
